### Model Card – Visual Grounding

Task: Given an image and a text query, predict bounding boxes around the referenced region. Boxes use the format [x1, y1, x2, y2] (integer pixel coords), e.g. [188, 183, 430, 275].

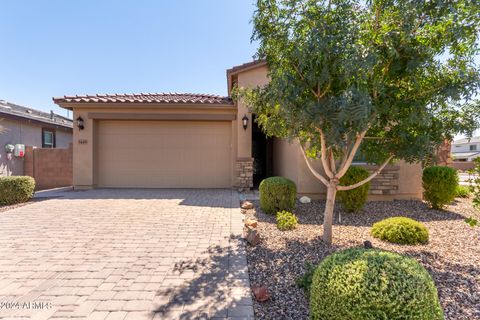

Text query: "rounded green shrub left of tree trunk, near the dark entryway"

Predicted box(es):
[258, 177, 297, 214]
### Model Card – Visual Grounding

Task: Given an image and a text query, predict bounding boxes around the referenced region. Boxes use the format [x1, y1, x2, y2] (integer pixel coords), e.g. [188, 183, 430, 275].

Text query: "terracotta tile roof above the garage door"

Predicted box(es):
[53, 93, 233, 105]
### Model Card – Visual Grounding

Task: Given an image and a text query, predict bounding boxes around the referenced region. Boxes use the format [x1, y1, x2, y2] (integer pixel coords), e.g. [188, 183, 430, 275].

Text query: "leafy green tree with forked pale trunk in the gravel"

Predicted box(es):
[237, 0, 480, 243]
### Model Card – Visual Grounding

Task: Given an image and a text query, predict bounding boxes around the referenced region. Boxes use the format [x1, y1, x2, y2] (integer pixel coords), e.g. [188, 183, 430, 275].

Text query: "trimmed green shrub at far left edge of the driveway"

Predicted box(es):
[0, 176, 35, 205]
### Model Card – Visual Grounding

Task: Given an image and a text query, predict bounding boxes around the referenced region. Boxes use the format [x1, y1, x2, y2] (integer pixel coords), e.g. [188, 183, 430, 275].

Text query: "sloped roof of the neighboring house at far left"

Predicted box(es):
[0, 100, 73, 128]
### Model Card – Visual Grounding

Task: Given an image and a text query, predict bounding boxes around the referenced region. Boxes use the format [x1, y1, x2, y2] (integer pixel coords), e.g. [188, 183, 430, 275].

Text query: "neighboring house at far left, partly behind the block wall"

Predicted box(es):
[0, 100, 73, 176]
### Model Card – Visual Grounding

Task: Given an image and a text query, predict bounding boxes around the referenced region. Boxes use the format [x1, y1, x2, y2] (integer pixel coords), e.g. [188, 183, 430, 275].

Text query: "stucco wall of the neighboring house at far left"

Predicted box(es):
[0, 117, 72, 176]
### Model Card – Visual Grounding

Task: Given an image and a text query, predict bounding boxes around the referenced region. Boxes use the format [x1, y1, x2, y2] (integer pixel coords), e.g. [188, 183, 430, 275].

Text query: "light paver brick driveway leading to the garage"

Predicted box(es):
[0, 189, 253, 320]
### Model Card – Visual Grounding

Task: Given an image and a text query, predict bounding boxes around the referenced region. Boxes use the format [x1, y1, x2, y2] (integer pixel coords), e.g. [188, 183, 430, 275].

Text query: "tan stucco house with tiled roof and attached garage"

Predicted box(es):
[53, 61, 422, 200]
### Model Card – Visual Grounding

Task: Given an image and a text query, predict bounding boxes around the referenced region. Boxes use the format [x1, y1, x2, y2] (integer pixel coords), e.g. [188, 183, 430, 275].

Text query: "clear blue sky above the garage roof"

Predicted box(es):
[0, 0, 256, 116]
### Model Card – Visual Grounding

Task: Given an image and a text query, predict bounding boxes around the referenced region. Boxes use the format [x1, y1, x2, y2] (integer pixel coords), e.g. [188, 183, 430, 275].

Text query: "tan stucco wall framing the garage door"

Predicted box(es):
[72, 103, 237, 189]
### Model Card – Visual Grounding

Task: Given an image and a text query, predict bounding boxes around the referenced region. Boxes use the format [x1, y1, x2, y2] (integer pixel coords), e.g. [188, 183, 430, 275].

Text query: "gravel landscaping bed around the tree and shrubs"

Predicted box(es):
[243, 199, 480, 320]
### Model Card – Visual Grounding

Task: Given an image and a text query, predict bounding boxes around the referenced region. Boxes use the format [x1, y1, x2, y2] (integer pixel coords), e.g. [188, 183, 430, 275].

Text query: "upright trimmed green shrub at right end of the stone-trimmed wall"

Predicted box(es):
[422, 166, 458, 209]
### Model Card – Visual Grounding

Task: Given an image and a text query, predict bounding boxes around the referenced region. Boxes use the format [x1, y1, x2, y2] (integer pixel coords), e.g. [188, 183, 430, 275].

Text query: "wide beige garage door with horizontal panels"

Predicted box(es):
[96, 120, 232, 188]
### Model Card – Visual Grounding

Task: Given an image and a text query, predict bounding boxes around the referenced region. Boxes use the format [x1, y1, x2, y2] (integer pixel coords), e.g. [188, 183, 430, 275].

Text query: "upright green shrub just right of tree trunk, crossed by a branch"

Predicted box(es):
[338, 167, 370, 212]
